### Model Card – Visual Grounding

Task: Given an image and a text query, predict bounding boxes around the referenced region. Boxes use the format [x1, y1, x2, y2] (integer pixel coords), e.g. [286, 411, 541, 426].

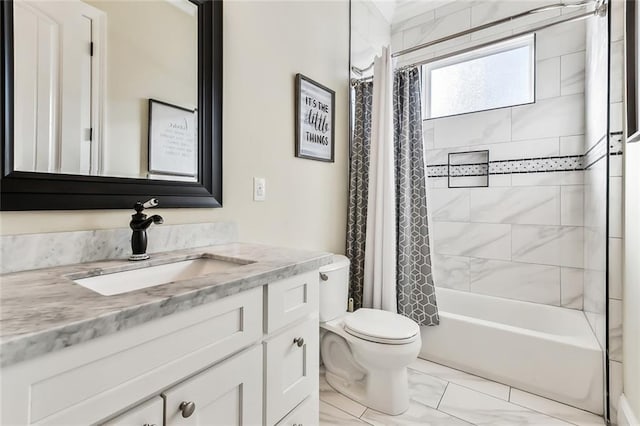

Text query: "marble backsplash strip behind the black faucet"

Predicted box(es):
[0, 222, 238, 274]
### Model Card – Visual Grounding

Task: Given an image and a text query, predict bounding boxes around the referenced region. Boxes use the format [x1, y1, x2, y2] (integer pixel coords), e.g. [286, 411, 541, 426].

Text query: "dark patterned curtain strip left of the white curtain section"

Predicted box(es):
[347, 82, 373, 309]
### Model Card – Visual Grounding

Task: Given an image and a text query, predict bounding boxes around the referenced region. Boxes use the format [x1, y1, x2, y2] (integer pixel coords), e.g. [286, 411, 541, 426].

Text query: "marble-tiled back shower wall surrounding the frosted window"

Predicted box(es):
[392, 1, 586, 309]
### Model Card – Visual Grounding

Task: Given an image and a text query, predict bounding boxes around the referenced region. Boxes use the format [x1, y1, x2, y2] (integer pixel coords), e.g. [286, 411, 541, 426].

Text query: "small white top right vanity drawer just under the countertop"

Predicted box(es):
[265, 270, 319, 333]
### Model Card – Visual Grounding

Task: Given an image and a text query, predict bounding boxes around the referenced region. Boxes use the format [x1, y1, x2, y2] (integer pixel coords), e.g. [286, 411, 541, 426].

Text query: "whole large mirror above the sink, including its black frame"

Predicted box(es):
[0, 0, 222, 210]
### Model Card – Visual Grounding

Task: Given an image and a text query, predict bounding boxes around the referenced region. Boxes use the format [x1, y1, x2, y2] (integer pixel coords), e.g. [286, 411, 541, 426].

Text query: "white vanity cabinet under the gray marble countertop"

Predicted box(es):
[0, 270, 319, 426]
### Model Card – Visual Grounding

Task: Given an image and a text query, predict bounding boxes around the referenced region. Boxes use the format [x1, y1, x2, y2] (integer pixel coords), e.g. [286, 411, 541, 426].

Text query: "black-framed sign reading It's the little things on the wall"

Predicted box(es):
[295, 73, 336, 163]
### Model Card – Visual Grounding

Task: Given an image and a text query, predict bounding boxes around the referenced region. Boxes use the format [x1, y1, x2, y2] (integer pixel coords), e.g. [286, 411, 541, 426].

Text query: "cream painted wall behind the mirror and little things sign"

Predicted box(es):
[0, 1, 349, 252]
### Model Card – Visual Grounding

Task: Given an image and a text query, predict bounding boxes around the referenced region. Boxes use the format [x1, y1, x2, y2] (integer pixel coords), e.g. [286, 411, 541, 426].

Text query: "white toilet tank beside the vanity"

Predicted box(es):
[319, 254, 349, 322]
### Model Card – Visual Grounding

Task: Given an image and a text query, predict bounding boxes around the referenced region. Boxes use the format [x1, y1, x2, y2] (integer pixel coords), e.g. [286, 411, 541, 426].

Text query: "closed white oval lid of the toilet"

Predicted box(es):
[344, 308, 420, 345]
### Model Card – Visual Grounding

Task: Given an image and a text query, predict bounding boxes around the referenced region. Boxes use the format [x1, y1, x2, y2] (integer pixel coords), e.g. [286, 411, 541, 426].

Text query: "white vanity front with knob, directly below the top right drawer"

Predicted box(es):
[265, 318, 319, 425]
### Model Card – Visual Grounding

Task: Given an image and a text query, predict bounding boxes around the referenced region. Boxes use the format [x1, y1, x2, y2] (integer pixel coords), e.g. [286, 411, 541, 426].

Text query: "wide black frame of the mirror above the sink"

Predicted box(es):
[0, 0, 222, 211]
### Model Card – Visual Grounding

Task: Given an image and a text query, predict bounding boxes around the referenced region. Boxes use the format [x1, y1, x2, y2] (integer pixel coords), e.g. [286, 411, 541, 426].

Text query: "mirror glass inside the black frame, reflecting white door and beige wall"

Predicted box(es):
[14, 0, 198, 181]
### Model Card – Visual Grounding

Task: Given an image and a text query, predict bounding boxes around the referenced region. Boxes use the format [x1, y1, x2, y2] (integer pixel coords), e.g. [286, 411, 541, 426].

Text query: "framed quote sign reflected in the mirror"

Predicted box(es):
[149, 99, 198, 176]
